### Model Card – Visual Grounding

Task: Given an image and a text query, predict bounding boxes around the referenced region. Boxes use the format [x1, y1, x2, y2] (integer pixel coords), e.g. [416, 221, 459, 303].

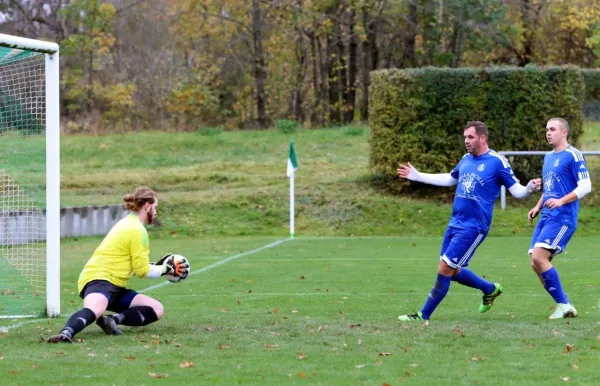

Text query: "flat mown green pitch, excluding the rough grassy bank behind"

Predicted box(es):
[0, 237, 600, 385]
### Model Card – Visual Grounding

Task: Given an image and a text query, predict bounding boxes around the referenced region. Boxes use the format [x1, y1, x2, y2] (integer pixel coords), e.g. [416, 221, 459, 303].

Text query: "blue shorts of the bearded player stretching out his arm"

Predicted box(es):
[440, 227, 487, 268]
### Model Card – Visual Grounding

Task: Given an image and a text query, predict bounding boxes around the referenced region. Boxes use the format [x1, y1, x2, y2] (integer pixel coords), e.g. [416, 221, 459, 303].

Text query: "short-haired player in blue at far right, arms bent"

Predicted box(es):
[528, 118, 592, 319]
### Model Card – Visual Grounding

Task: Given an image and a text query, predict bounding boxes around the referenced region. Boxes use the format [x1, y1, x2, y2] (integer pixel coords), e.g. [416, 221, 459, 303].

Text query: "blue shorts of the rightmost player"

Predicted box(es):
[529, 216, 576, 257]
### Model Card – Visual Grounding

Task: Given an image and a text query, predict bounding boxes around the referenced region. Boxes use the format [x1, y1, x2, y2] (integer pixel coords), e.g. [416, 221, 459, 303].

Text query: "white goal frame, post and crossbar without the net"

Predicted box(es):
[0, 34, 60, 317]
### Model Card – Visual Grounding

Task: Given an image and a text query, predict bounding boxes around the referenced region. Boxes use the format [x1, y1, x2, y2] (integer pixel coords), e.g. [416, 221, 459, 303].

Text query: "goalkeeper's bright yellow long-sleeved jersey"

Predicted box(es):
[78, 213, 150, 292]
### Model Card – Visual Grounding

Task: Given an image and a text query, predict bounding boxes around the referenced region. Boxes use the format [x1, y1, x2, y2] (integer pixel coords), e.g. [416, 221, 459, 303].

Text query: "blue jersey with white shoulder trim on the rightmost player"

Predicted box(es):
[542, 145, 590, 226]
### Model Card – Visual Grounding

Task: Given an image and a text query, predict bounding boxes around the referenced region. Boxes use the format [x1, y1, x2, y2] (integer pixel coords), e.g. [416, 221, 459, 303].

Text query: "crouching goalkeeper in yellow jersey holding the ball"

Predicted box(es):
[48, 186, 189, 343]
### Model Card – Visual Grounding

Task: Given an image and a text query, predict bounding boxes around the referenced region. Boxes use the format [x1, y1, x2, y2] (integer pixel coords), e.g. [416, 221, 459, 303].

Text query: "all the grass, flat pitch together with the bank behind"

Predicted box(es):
[0, 124, 600, 385]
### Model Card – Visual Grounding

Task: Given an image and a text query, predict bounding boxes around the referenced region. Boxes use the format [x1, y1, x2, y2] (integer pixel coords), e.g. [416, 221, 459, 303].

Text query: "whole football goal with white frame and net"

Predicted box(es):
[0, 34, 60, 318]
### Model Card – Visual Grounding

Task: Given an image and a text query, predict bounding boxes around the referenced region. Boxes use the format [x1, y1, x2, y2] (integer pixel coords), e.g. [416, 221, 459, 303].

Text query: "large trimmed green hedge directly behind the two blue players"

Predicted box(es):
[369, 66, 584, 190]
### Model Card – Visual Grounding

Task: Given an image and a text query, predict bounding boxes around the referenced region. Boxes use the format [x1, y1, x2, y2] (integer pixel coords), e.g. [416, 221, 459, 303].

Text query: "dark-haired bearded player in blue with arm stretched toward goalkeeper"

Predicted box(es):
[398, 121, 541, 323]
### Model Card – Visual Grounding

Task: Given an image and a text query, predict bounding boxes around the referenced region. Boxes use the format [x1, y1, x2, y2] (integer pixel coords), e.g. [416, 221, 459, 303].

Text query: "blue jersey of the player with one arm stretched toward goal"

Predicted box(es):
[448, 150, 519, 232]
